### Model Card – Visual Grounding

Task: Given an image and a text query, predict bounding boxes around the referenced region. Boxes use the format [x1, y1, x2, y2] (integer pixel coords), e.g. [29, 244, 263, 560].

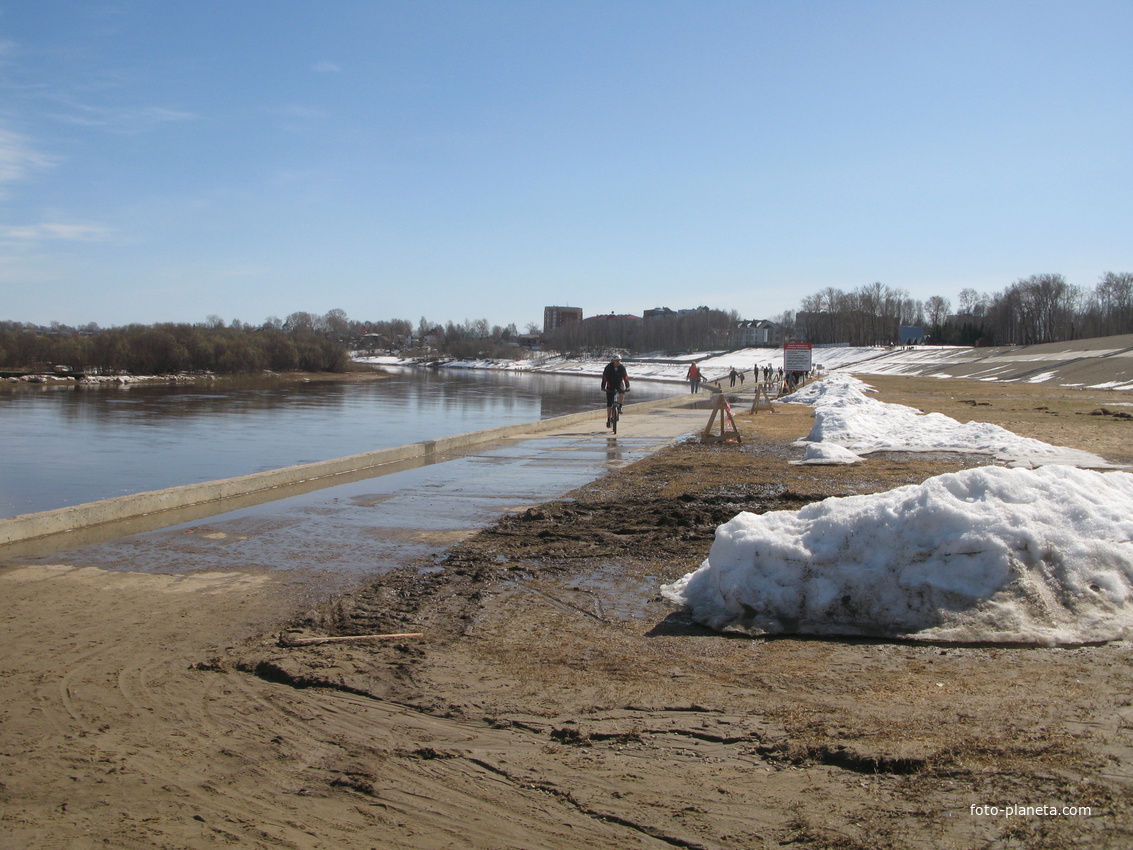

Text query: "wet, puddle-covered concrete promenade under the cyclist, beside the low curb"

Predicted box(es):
[0, 402, 708, 598]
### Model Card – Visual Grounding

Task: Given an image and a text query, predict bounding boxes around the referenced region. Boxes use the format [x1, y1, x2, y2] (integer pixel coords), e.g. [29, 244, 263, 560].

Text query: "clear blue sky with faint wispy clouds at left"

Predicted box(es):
[0, 0, 1133, 330]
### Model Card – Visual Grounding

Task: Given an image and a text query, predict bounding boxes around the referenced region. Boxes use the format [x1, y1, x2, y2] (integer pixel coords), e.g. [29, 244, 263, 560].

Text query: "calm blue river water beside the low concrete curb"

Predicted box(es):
[0, 368, 685, 517]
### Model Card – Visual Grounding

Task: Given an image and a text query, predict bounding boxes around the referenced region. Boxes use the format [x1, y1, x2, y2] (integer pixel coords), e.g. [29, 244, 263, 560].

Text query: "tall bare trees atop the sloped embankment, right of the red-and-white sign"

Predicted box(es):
[787, 272, 1133, 346]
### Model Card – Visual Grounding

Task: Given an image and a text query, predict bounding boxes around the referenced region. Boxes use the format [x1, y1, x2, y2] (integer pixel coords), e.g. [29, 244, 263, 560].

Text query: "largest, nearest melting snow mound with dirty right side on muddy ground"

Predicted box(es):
[662, 466, 1133, 644]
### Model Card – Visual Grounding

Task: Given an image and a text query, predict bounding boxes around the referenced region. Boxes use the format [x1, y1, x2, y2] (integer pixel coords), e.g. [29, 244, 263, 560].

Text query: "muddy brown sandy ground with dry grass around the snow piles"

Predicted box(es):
[0, 379, 1133, 849]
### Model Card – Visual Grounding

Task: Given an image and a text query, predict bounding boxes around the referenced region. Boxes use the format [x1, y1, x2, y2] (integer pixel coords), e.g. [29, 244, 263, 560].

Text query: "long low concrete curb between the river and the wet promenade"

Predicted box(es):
[0, 396, 692, 545]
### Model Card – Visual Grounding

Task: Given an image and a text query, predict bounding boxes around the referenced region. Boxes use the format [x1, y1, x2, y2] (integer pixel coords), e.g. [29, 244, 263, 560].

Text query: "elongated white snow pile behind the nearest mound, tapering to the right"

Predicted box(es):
[782, 374, 1111, 468]
